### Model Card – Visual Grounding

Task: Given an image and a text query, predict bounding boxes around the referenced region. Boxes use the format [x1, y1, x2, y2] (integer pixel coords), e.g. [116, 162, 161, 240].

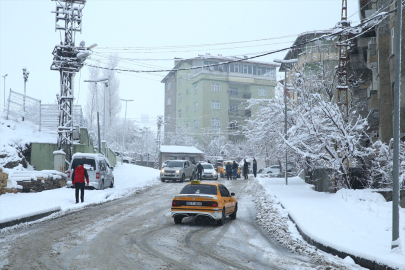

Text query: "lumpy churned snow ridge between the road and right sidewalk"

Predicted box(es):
[246, 178, 347, 270]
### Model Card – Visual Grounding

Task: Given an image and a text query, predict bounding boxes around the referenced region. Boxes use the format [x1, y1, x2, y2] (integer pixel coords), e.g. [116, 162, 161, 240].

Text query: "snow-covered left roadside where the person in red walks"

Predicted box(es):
[0, 164, 162, 230]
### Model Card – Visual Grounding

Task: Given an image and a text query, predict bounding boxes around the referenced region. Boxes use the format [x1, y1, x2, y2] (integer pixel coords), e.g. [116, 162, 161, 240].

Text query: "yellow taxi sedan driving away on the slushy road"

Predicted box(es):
[172, 180, 238, 225]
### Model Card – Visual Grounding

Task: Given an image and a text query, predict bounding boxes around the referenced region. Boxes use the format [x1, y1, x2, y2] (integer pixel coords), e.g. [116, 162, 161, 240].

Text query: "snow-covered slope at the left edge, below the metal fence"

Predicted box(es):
[0, 118, 57, 168]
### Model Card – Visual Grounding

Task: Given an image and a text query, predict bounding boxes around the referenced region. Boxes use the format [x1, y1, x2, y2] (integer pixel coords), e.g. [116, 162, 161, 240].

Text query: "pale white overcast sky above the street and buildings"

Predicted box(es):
[0, 0, 359, 127]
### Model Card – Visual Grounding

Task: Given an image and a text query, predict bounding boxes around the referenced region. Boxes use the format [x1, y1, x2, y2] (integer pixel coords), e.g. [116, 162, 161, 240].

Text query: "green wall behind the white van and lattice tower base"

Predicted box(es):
[31, 128, 117, 171]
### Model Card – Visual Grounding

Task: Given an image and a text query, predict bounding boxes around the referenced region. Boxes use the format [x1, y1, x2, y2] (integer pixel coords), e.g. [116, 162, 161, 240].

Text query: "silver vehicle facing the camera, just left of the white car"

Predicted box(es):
[160, 160, 197, 183]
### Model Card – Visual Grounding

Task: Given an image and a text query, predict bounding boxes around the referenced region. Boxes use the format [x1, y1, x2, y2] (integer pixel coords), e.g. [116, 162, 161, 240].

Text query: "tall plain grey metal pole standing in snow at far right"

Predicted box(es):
[391, 0, 402, 253]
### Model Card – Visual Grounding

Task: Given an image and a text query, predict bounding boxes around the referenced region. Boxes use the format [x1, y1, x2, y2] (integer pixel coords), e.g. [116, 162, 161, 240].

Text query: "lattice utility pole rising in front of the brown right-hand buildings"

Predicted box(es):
[336, 0, 350, 121]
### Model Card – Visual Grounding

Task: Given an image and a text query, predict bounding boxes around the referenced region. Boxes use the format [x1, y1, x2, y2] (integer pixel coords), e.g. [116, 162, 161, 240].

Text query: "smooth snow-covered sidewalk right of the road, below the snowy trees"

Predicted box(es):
[257, 177, 405, 269]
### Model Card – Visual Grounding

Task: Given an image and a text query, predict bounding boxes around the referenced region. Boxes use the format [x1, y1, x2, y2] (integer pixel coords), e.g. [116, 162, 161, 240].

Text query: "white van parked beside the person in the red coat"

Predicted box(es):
[66, 153, 114, 189]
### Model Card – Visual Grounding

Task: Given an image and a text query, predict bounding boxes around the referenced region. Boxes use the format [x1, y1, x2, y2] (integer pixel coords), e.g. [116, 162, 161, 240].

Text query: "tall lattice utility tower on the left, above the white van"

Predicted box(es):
[51, 0, 97, 161]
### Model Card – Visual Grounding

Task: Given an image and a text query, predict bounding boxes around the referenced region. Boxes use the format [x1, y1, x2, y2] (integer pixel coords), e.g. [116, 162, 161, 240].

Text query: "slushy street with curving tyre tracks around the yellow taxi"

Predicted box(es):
[0, 164, 361, 269]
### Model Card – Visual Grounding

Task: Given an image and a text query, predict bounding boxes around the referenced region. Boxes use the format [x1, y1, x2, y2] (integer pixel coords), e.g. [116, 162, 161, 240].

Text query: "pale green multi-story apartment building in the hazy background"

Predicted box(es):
[162, 55, 279, 143]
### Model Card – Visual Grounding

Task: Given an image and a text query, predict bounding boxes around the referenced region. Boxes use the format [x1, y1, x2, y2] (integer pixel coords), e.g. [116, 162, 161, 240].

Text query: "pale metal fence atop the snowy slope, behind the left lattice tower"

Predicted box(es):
[6, 90, 86, 132]
